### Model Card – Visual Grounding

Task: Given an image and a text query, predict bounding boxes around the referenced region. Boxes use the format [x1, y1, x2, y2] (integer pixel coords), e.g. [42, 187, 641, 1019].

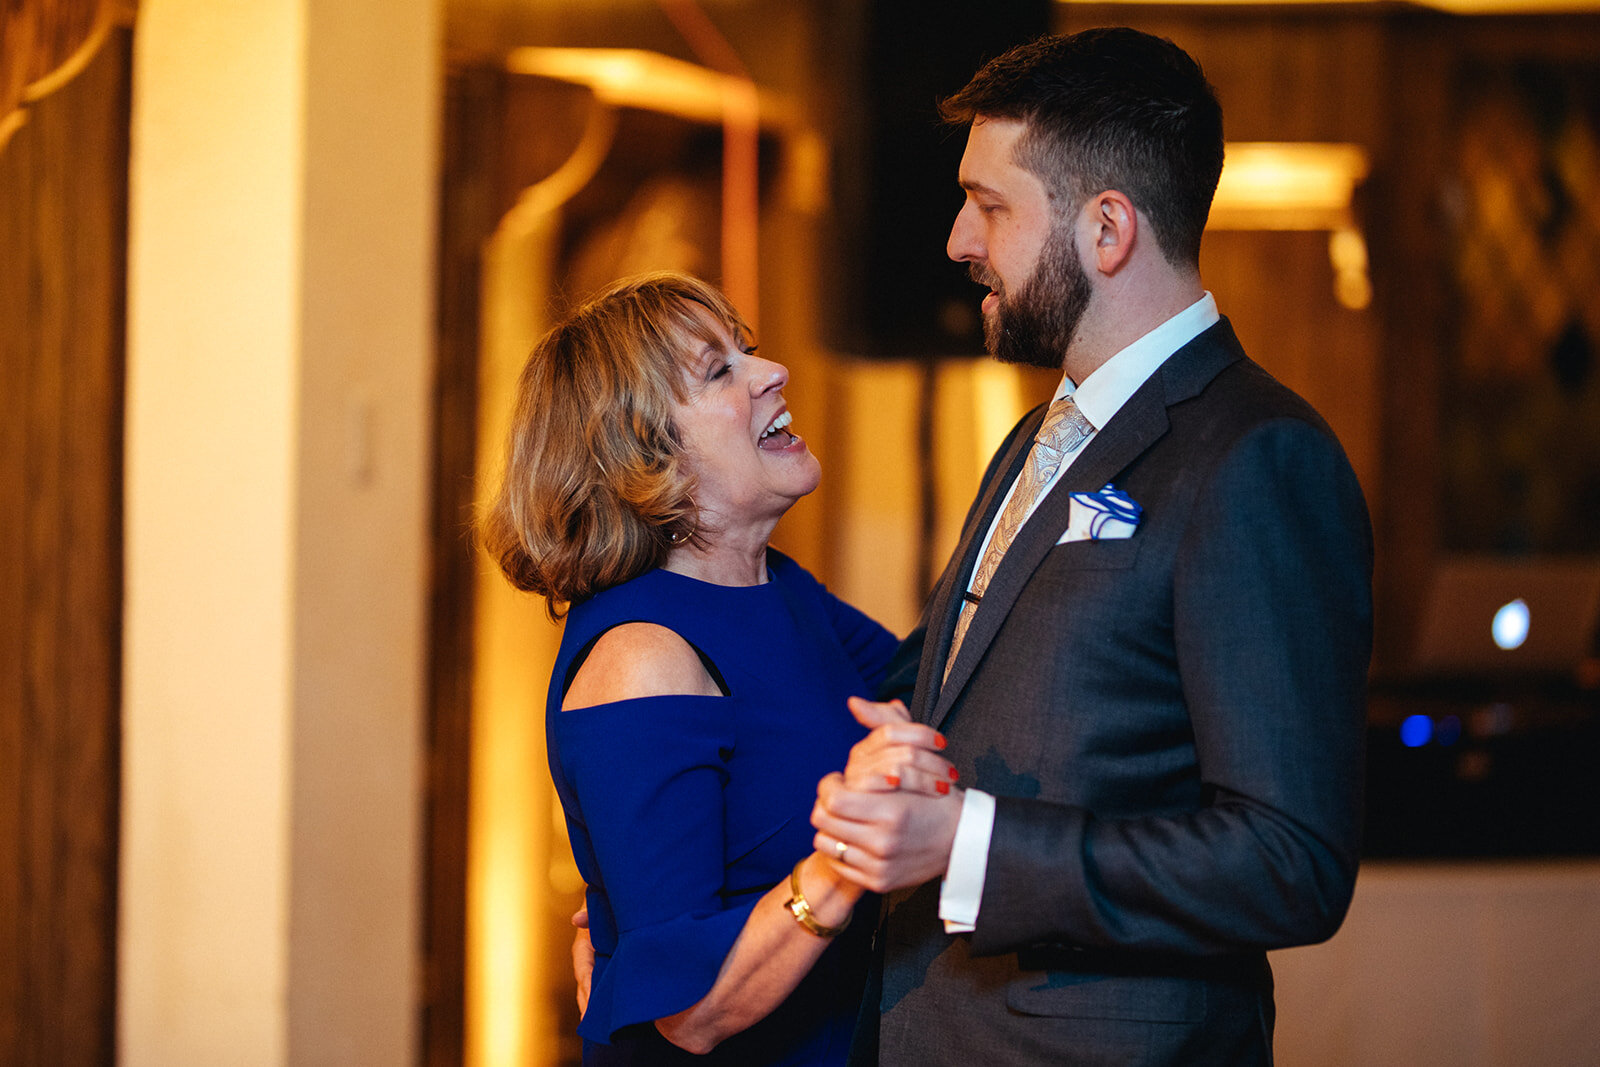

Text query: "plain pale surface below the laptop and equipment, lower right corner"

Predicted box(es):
[1272, 857, 1600, 1067]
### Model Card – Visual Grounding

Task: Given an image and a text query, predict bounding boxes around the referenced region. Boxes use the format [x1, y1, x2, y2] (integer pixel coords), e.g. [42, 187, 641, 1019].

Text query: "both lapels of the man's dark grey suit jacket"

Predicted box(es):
[918, 318, 1243, 728]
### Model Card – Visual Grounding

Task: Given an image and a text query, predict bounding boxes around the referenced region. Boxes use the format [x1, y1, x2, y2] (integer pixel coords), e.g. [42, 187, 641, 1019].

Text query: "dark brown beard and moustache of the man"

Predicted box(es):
[968, 226, 1093, 370]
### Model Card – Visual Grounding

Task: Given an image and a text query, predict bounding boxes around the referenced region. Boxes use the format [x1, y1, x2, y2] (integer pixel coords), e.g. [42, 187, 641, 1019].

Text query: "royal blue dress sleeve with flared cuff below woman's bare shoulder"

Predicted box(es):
[554, 696, 760, 1041]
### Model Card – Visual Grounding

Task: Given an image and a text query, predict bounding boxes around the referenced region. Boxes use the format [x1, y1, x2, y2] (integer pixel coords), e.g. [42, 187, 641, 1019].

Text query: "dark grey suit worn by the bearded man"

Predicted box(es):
[853, 318, 1371, 1067]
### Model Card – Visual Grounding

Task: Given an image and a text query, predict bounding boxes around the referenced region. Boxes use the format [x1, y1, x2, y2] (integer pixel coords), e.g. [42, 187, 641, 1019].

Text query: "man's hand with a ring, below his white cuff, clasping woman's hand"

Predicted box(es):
[811, 773, 962, 893]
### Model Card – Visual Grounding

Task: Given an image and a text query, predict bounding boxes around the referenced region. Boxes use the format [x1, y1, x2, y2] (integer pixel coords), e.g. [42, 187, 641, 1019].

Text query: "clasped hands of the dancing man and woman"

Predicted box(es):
[811, 697, 962, 893]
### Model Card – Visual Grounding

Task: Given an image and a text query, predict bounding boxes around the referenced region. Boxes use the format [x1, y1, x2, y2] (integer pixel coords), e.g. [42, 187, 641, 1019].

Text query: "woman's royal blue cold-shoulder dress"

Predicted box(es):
[546, 550, 896, 1067]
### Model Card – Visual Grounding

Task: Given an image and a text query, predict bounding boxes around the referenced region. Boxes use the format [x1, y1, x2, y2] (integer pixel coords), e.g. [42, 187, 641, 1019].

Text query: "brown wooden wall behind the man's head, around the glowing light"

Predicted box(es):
[1062, 5, 1600, 675]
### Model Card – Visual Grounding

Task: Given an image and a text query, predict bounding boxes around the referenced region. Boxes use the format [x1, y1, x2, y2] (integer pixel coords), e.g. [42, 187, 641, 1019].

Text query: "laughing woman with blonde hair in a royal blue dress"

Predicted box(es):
[482, 274, 952, 1065]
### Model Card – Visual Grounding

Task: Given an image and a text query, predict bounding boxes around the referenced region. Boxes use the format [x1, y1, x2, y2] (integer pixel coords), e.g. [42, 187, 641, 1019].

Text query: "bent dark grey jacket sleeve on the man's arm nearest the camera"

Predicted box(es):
[971, 418, 1371, 955]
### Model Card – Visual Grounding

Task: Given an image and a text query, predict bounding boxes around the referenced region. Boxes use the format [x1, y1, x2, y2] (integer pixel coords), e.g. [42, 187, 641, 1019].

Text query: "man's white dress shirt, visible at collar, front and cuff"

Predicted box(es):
[939, 293, 1221, 934]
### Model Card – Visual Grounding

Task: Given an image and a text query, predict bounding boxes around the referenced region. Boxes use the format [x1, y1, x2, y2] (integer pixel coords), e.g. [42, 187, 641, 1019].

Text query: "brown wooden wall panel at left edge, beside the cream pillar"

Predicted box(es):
[0, 30, 131, 1067]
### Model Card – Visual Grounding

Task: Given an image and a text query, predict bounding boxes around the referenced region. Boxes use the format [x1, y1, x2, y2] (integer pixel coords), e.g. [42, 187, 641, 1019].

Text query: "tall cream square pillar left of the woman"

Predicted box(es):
[118, 0, 440, 1067]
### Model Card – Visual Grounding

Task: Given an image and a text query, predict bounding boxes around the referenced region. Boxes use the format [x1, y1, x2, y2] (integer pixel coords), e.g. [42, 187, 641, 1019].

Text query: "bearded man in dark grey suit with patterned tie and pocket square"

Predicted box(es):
[813, 29, 1371, 1067]
